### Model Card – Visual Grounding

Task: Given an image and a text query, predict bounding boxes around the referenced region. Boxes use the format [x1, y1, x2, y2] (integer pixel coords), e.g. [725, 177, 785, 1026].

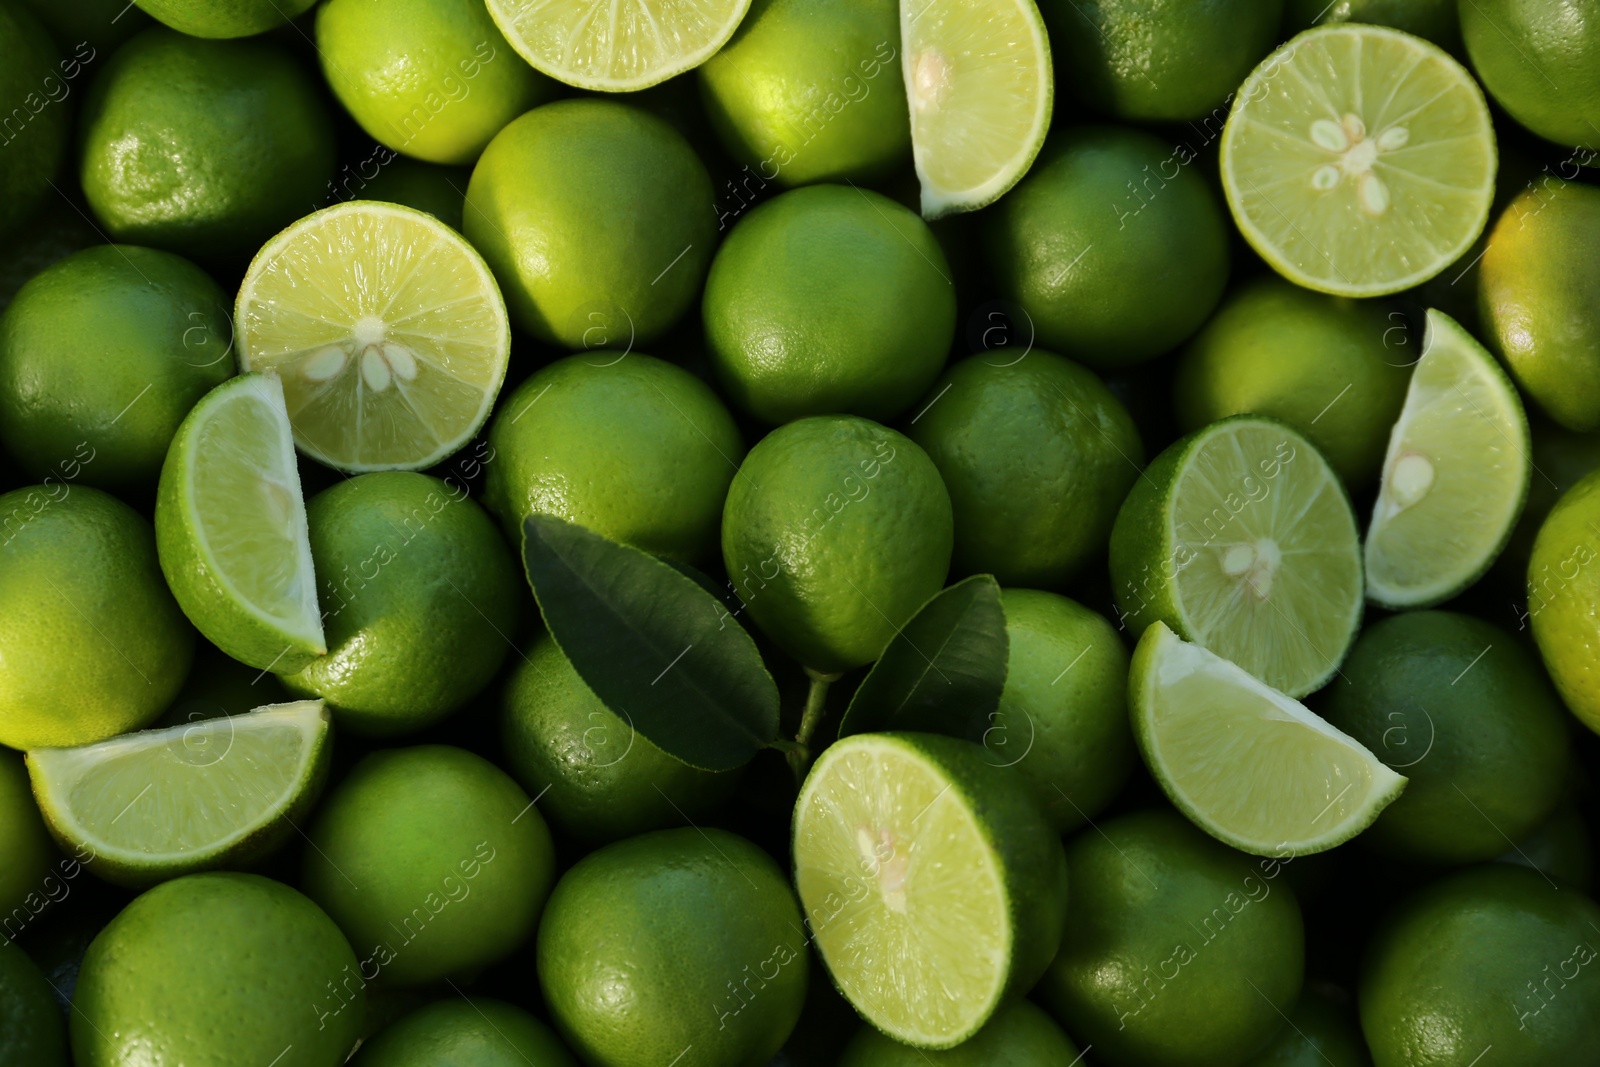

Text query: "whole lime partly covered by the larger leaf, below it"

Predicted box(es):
[501, 633, 739, 841]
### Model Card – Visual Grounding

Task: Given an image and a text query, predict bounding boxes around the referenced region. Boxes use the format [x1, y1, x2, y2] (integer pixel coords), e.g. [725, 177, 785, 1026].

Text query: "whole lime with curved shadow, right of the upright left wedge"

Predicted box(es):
[283, 470, 522, 736]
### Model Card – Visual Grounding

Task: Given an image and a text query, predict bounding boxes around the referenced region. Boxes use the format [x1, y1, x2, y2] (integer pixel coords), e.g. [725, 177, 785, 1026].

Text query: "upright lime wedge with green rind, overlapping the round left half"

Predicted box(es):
[155, 374, 328, 670]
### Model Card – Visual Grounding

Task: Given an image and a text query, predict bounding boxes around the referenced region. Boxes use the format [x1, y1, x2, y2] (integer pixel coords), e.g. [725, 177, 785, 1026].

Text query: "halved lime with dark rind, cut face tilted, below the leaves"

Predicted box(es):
[794, 734, 1067, 1048]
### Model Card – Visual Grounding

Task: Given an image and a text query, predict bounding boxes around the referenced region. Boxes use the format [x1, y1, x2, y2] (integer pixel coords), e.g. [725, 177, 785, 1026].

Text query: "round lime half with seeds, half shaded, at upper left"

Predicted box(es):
[235, 200, 510, 472]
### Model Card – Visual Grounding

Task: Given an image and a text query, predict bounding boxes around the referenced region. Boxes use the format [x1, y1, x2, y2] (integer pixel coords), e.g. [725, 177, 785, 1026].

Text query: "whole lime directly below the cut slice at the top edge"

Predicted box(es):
[462, 100, 715, 349]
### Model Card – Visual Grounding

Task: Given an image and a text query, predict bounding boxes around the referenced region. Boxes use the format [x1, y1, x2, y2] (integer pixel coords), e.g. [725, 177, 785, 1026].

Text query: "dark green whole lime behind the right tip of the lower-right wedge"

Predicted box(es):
[1320, 611, 1570, 864]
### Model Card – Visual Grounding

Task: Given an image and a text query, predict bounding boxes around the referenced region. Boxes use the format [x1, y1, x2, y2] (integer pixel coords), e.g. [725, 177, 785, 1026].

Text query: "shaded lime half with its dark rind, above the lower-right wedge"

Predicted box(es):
[1110, 414, 1362, 697]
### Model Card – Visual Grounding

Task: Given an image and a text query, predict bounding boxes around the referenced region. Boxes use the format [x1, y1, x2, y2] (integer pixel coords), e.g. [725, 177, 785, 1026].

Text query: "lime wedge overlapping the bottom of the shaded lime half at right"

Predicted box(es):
[1130, 622, 1406, 857]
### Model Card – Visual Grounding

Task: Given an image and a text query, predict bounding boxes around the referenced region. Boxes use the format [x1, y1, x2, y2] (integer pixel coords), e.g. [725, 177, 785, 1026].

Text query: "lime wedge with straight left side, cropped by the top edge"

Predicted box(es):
[901, 0, 1054, 219]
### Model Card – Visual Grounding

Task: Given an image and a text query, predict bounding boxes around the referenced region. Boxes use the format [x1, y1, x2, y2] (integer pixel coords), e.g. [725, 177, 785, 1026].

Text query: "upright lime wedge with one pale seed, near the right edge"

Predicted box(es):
[1366, 310, 1533, 609]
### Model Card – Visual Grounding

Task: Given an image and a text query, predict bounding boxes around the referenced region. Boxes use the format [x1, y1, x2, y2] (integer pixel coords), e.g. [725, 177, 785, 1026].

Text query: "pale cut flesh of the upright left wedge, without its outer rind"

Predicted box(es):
[186, 376, 326, 649]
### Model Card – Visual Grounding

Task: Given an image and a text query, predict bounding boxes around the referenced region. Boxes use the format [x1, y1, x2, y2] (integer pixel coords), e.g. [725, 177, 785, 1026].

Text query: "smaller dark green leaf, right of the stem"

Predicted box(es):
[838, 574, 1010, 741]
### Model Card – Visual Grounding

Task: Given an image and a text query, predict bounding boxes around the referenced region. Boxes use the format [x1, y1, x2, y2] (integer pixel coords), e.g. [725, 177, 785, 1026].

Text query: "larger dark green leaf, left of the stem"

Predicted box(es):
[522, 515, 778, 771]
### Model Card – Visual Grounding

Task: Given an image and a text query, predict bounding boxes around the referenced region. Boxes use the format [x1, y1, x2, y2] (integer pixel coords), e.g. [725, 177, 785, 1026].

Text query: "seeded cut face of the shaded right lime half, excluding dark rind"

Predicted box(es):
[1168, 419, 1362, 697]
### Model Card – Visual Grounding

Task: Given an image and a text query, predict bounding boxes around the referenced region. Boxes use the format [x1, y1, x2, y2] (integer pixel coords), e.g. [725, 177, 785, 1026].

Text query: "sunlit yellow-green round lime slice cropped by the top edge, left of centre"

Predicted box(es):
[488, 0, 750, 93]
